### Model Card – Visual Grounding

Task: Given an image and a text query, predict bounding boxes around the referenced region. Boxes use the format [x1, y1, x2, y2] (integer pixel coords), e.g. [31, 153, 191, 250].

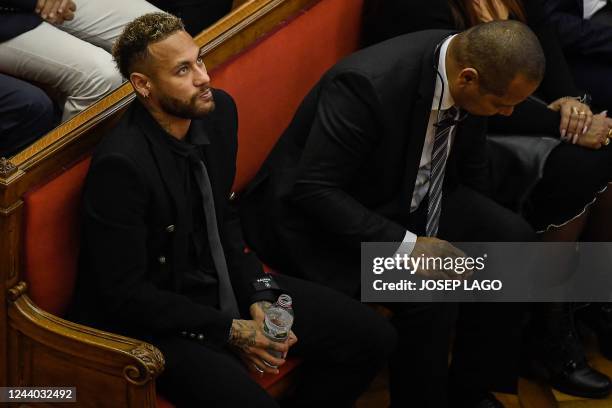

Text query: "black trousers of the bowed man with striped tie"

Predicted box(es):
[386, 186, 536, 408]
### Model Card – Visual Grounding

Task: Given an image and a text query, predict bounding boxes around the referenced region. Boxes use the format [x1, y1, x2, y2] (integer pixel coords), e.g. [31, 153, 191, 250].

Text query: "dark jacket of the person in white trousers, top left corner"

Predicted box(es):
[0, 0, 42, 42]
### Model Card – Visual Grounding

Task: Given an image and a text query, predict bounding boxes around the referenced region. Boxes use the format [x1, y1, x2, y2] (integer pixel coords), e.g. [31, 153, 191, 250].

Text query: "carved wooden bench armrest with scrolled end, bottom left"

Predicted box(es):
[8, 282, 164, 408]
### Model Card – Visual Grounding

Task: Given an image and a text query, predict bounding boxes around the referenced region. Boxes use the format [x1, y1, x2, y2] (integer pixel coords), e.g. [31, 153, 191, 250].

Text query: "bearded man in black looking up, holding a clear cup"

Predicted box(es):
[72, 13, 395, 407]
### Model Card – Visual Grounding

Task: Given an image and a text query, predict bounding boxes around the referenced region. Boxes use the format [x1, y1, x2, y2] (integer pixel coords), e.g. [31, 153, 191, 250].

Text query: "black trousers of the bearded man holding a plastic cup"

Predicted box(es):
[153, 276, 396, 408]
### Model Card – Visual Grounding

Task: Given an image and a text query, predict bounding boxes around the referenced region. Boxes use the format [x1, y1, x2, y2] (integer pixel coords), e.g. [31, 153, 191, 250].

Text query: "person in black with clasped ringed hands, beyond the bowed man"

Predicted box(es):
[369, 0, 612, 397]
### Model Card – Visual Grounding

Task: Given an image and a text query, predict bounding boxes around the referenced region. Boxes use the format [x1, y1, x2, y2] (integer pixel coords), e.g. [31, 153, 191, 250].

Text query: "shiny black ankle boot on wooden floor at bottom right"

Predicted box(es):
[528, 302, 612, 398]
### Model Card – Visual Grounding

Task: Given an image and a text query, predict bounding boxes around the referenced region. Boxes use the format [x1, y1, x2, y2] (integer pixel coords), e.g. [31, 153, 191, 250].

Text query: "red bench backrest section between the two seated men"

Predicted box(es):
[211, 0, 363, 191]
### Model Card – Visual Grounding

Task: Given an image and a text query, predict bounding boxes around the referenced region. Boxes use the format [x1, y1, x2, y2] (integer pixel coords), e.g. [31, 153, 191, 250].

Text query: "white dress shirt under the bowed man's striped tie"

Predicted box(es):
[402, 35, 455, 253]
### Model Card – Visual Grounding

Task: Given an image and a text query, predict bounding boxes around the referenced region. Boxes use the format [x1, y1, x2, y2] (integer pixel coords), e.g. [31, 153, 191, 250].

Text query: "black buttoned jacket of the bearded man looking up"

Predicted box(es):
[72, 90, 270, 343]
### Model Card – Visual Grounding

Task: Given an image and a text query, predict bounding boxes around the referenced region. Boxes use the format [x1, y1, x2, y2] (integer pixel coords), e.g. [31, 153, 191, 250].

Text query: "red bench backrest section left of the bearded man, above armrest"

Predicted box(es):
[23, 158, 90, 316]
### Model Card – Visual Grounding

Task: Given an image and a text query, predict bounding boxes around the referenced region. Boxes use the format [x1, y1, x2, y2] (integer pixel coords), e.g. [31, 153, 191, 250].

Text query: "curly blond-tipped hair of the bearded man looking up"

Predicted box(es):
[113, 12, 185, 79]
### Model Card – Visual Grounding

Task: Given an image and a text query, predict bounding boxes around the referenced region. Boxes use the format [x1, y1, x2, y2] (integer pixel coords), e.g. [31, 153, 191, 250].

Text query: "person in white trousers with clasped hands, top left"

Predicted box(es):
[0, 0, 159, 121]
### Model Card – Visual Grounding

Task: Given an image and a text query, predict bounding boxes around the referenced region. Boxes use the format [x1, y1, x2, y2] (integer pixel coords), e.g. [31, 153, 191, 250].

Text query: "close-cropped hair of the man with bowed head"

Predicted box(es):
[454, 20, 546, 96]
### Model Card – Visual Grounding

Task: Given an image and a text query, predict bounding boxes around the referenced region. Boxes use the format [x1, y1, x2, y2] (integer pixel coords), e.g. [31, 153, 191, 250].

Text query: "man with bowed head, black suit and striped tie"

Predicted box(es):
[243, 21, 544, 408]
